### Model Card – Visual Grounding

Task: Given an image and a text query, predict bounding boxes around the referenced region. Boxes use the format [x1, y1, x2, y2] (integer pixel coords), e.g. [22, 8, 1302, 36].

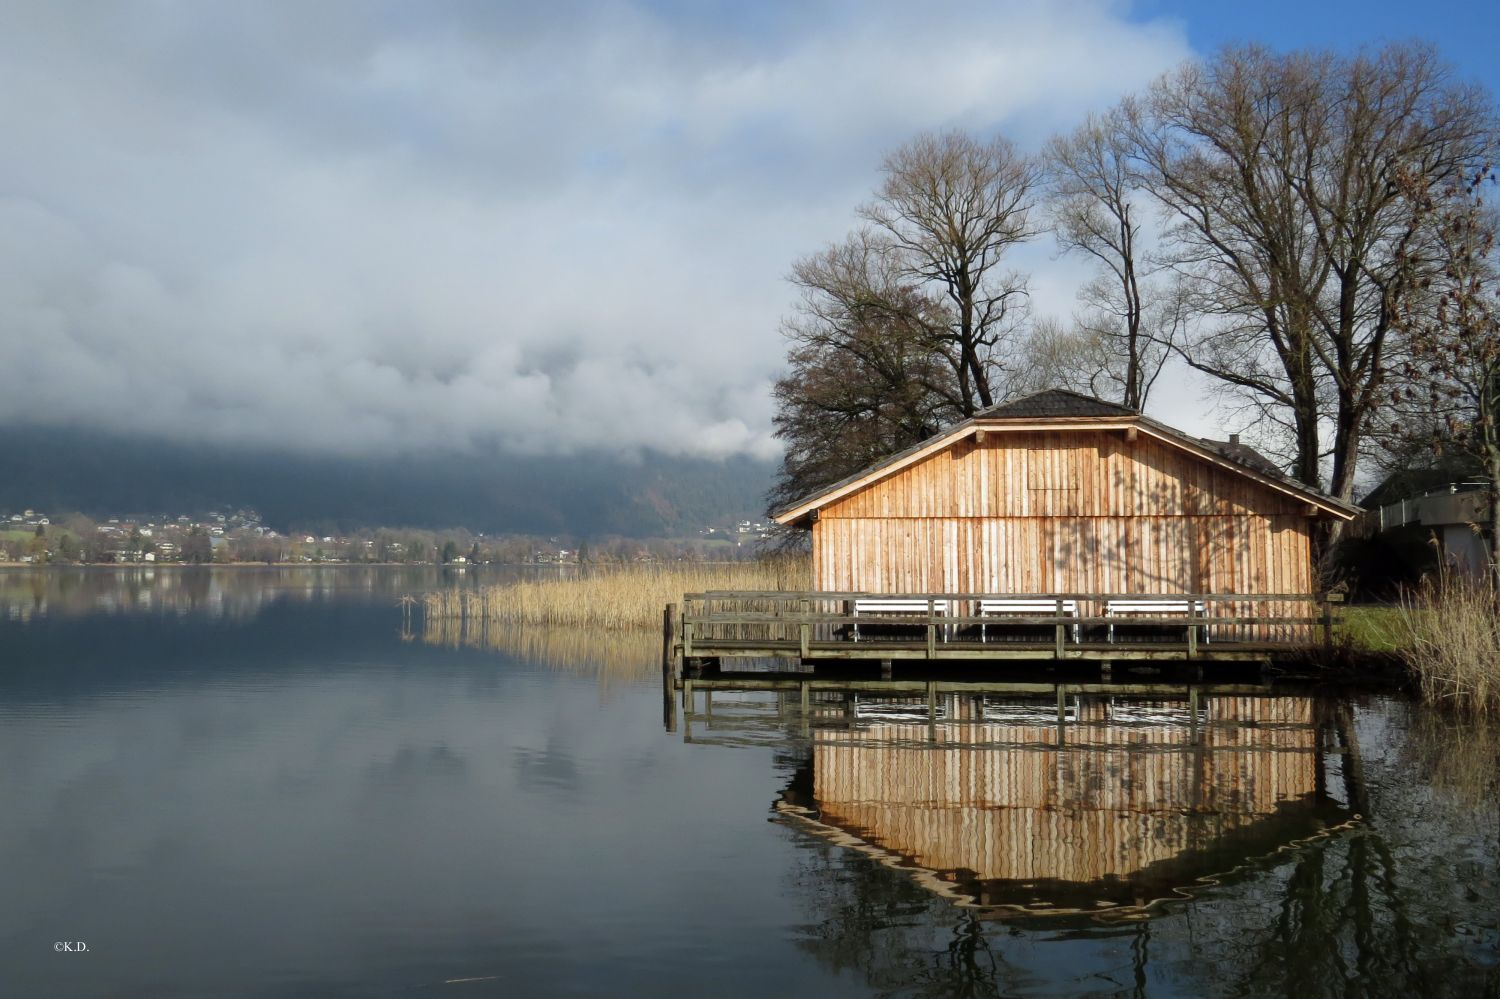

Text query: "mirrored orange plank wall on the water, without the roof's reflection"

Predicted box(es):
[813, 698, 1319, 882]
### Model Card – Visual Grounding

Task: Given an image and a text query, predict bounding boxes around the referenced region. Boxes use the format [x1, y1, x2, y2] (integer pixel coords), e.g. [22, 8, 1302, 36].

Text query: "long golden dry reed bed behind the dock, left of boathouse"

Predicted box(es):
[422, 558, 812, 630]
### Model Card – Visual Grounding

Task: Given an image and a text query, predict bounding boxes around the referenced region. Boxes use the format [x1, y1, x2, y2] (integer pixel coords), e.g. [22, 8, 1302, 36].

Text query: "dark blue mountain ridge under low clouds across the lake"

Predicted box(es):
[0, 426, 776, 537]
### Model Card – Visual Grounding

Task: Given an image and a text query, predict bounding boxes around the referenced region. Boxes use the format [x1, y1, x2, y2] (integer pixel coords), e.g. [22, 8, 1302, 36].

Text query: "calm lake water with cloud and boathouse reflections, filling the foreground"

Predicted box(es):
[0, 569, 1500, 999]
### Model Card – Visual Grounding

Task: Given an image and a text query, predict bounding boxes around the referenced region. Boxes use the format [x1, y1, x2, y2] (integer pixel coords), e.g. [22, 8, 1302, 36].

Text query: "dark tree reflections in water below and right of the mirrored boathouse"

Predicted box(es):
[795, 702, 1500, 998]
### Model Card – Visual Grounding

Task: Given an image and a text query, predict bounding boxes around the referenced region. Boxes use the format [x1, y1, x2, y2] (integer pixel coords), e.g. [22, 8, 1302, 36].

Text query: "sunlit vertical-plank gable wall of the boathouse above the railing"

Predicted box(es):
[813, 431, 1314, 630]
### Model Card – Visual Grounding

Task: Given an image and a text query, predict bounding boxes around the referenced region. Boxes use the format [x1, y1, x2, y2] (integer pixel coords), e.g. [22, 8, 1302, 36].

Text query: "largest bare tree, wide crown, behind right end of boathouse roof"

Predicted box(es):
[1121, 44, 1494, 500]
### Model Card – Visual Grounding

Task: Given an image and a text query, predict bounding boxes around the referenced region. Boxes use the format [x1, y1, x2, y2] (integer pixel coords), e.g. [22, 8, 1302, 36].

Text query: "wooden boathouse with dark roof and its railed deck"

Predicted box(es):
[680, 390, 1359, 662]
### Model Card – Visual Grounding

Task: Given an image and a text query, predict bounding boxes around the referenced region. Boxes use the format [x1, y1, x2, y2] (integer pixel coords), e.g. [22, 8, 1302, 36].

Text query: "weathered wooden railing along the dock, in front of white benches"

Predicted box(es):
[680, 591, 1335, 659]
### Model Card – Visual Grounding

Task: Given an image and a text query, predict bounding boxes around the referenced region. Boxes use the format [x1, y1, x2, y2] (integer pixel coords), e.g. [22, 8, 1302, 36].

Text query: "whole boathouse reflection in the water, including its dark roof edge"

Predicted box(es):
[779, 696, 1358, 912]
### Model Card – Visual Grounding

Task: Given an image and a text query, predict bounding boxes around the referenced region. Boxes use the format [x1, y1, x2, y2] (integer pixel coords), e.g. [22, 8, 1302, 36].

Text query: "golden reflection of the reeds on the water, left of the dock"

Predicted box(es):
[422, 617, 662, 680]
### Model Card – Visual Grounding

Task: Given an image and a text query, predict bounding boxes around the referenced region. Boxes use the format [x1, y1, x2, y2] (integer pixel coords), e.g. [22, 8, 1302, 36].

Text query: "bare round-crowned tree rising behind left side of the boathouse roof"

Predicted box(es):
[860, 132, 1038, 416]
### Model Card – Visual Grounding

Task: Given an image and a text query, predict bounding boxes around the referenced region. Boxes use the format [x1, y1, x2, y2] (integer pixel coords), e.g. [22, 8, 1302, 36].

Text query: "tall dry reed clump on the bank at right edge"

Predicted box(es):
[1400, 576, 1500, 717]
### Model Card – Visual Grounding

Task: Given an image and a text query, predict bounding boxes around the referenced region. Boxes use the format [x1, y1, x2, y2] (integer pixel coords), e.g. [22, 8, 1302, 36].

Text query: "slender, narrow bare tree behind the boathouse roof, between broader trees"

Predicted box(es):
[1044, 111, 1184, 410]
